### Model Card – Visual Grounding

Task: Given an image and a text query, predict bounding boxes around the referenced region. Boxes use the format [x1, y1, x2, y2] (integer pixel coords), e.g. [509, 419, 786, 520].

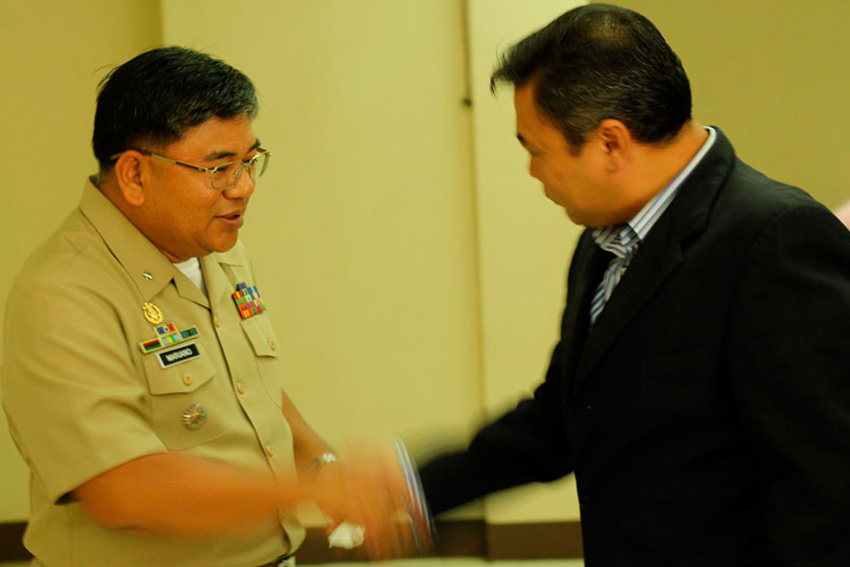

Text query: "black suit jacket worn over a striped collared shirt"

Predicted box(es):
[420, 130, 850, 567]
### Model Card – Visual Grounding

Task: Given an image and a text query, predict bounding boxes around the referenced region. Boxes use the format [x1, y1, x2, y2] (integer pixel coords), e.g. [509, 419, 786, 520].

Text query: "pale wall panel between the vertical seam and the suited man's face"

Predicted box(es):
[468, 0, 585, 523]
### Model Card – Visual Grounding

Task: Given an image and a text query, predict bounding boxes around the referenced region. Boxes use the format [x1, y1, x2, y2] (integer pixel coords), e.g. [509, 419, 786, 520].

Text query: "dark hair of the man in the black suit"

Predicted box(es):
[490, 4, 691, 151]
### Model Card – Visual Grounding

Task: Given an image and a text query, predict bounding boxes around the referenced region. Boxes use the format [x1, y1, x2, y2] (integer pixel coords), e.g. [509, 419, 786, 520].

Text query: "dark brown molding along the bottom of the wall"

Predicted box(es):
[0, 520, 582, 565]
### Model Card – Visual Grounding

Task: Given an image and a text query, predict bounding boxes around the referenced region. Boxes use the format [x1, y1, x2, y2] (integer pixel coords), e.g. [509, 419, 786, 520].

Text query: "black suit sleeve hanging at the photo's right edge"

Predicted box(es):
[729, 204, 850, 566]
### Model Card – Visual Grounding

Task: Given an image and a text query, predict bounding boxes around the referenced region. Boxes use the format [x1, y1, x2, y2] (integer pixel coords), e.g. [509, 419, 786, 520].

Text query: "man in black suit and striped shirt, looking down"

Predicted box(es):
[421, 4, 850, 567]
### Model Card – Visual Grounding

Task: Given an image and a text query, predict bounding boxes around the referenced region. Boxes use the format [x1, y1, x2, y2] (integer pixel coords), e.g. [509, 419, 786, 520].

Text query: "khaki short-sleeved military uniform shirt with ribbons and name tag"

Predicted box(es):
[2, 183, 304, 567]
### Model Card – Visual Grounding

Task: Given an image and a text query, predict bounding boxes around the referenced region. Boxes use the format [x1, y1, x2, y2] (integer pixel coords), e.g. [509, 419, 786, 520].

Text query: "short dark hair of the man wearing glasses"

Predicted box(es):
[92, 47, 257, 170]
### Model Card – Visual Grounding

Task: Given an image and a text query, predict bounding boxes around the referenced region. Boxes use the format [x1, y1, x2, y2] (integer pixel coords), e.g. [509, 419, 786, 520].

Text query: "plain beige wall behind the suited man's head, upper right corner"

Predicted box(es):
[596, 0, 850, 208]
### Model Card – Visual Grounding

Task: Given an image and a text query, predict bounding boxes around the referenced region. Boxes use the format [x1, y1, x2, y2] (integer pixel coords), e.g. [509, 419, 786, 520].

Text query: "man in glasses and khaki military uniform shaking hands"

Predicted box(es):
[2, 48, 416, 567]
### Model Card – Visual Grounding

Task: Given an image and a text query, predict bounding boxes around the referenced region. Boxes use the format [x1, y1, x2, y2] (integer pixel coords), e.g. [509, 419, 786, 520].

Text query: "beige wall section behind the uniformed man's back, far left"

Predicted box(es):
[0, 0, 160, 522]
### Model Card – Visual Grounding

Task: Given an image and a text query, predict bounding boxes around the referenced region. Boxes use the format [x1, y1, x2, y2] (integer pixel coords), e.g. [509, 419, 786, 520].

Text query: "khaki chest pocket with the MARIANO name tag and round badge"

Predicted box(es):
[144, 343, 226, 451]
